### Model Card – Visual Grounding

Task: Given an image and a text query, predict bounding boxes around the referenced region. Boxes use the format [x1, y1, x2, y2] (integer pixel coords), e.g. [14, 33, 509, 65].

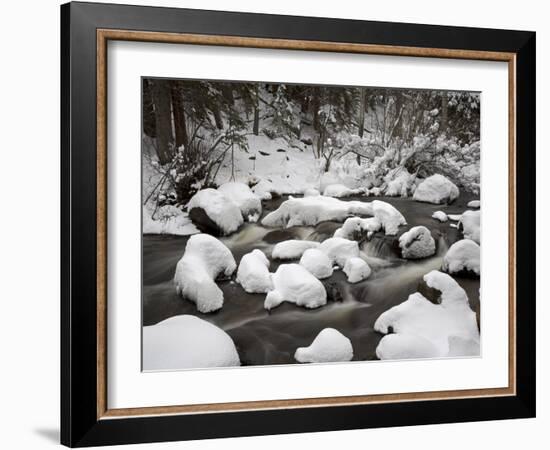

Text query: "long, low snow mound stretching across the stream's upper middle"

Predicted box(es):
[262, 195, 373, 228]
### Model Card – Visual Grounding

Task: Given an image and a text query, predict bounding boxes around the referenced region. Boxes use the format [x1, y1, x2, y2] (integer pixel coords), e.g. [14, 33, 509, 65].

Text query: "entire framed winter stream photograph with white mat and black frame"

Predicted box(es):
[61, 3, 536, 447]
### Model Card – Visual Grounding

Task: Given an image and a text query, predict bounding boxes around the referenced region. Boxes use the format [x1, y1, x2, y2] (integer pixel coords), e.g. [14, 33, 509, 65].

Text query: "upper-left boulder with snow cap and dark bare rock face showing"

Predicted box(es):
[187, 188, 243, 236]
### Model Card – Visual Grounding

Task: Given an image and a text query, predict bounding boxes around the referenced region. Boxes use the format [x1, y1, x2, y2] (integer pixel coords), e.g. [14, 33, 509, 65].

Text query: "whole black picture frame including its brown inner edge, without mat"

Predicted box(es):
[61, 2, 535, 447]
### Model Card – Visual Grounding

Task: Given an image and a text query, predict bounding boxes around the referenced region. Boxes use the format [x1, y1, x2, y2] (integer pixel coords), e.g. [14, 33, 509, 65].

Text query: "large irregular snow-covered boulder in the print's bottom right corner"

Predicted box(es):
[374, 270, 480, 359]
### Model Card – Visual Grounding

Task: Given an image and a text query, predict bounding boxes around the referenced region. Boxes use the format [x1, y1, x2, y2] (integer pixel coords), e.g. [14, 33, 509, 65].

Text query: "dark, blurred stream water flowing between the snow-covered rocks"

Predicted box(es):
[143, 195, 479, 365]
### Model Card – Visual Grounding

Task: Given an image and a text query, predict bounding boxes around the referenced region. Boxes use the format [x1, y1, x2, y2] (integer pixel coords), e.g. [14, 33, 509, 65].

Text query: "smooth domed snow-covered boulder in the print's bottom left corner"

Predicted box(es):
[143, 315, 241, 370]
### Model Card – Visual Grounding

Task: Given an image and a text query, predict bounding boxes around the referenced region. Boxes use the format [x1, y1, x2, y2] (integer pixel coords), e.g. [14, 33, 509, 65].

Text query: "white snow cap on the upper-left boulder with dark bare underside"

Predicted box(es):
[187, 188, 243, 235]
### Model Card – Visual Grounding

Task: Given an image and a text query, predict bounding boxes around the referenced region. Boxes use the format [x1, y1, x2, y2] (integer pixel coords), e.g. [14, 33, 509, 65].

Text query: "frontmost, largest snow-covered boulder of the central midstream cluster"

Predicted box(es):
[264, 264, 327, 310]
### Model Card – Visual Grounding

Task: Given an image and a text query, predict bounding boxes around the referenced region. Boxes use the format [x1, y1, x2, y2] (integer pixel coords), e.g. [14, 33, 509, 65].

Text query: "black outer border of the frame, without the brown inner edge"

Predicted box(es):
[60, 3, 536, 447]
